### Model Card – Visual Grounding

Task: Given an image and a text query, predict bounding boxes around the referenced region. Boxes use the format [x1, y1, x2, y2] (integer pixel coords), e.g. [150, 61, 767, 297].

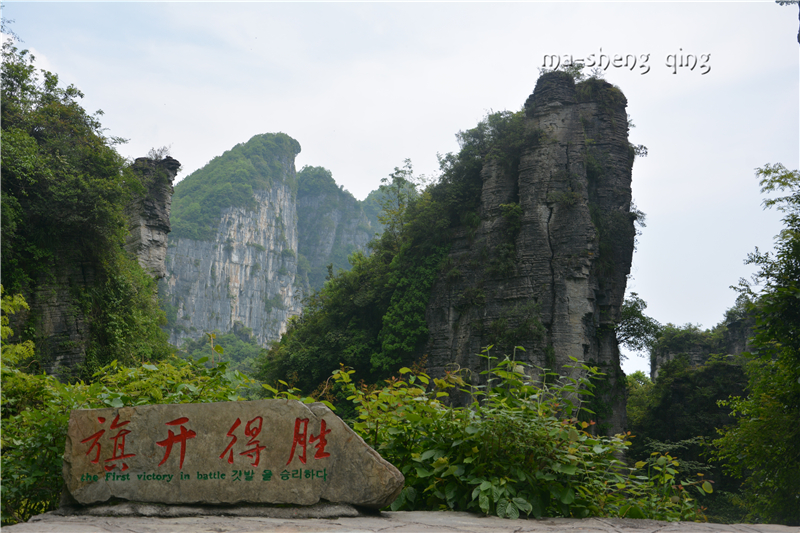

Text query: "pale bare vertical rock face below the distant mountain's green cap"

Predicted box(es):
[160, 181, 300, 345]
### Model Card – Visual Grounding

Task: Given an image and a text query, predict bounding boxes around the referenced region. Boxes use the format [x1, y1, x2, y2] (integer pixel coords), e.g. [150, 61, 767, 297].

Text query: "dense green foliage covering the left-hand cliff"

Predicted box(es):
[0, 31, 173, 376]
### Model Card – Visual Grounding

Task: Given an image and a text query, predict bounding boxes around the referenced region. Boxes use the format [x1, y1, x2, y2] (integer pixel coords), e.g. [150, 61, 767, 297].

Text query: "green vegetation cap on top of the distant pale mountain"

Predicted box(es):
[170, 133, 300, 240]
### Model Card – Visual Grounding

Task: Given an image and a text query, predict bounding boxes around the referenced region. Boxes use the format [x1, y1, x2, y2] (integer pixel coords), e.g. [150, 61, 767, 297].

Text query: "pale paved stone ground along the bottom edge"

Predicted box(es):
[4, 512, 800, 533]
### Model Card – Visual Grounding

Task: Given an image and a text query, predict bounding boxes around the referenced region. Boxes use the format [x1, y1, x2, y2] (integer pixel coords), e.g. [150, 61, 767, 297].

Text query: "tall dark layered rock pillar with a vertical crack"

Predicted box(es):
[425, 72, 636, 431]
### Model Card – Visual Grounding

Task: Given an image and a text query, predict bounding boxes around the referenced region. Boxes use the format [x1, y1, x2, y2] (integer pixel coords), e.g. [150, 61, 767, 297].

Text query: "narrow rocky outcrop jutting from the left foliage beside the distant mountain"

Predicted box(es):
[125, 156, 181, 279]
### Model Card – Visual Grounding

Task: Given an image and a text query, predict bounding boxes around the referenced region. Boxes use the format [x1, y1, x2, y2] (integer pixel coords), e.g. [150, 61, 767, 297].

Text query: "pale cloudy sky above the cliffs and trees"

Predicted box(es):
[3, 1, 800, 373]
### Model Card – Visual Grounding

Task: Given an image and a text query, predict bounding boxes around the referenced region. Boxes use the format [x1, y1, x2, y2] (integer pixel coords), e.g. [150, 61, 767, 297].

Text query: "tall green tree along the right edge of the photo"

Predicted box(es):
[715, 164, 800, 526]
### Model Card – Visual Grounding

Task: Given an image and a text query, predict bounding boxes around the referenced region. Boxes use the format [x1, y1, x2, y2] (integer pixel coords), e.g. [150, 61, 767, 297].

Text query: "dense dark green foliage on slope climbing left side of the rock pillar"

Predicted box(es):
[259, 111, 527, 391]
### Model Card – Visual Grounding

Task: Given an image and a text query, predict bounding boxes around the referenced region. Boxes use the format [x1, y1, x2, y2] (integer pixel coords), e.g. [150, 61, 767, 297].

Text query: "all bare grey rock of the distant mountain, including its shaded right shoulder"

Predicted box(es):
[159, 158, 379, 347]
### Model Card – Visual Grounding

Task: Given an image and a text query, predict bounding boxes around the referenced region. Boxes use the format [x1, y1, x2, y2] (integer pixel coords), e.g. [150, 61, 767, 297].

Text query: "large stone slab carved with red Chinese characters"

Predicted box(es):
[64, 400, 405, 508]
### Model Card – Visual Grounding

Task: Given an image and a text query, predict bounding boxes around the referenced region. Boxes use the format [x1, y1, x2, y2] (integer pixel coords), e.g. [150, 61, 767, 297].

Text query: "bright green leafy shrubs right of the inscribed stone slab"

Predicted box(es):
[334, 352, 712, 520]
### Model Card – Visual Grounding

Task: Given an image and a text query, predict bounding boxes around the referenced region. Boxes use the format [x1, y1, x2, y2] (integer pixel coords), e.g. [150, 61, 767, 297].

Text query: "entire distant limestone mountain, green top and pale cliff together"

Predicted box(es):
[159, 134, 382, 346]
